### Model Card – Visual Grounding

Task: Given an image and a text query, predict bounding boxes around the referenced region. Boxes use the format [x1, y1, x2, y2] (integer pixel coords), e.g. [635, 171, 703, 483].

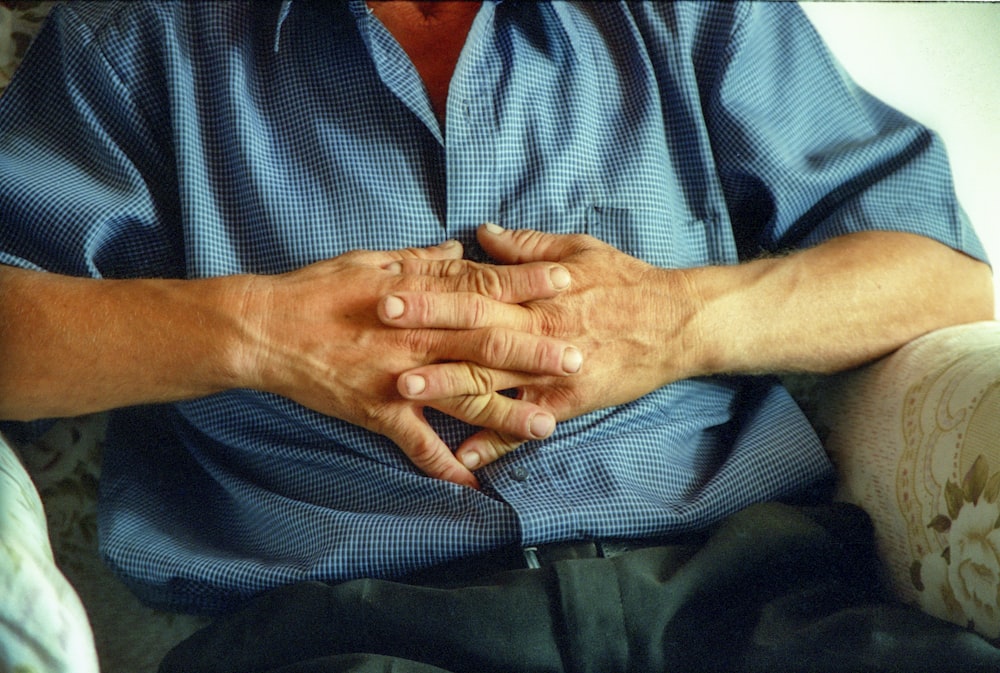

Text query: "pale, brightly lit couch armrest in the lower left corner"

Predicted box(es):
[0, 428, 98, 673]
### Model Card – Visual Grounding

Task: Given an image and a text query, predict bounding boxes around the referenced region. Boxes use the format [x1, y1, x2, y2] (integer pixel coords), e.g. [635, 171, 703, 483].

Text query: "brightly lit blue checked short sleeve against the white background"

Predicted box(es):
[706, 2, 986, 260]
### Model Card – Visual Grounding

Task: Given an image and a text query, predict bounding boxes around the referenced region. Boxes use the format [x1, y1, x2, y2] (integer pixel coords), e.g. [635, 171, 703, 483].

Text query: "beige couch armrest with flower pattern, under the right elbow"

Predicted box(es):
[814, 322, 1000, 638]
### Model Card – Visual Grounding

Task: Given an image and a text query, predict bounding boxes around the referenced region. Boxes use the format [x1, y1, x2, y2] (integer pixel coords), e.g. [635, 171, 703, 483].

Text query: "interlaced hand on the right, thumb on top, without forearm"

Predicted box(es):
[380, 225, 698, 469]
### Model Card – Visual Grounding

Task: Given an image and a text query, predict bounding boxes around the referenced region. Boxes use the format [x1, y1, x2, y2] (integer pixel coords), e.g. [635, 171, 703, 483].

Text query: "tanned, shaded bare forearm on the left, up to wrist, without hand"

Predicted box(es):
[0, 267, 249, 420]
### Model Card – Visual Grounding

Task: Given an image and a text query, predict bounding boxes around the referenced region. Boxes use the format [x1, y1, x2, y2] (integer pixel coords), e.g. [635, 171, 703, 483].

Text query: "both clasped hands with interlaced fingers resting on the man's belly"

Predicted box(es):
[248, 220, 690, 488]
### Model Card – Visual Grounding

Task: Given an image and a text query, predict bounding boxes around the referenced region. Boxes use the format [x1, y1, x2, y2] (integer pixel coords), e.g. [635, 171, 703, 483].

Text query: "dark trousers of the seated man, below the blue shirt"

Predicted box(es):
[160, 504, 1000, 673]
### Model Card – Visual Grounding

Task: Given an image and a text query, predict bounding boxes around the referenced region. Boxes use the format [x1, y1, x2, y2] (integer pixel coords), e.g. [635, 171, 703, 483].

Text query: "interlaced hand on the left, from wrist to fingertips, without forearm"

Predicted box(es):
[214, 243, 578, 487]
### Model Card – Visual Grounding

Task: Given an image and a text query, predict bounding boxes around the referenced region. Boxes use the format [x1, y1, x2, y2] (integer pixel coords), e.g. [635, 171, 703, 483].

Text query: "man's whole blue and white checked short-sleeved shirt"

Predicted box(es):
[0, 2, 984, 610]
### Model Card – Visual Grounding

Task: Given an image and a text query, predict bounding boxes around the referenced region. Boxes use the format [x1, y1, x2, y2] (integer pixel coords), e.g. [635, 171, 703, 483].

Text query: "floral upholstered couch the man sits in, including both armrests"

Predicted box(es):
[0, 2, 1000, 673]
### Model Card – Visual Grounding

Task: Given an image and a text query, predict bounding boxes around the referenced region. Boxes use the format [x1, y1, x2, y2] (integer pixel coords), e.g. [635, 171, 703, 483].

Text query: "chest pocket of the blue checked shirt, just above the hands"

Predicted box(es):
[585, 205, 712, 269]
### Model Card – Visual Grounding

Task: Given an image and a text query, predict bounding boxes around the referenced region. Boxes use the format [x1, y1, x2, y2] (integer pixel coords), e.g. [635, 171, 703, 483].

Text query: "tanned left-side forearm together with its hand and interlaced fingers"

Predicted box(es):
[0, 243, 579, 487]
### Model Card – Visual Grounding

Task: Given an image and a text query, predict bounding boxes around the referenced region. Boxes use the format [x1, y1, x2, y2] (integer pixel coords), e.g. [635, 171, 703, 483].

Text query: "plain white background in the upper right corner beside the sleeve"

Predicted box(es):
[801, 0, 1000, 313]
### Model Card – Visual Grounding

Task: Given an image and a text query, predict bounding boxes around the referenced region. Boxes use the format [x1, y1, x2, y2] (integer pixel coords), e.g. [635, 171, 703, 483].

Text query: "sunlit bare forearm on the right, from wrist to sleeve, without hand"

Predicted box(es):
[688, 232, 993, 374]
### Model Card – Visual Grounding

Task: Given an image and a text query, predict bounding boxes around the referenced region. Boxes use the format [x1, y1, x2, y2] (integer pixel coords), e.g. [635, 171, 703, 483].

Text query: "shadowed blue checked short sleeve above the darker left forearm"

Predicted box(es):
[0, 6, 183, 277]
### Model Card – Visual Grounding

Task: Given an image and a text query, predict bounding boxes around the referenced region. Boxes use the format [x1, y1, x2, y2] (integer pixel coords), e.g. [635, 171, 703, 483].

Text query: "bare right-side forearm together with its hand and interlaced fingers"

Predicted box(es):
[383, 226, 993, 466]
